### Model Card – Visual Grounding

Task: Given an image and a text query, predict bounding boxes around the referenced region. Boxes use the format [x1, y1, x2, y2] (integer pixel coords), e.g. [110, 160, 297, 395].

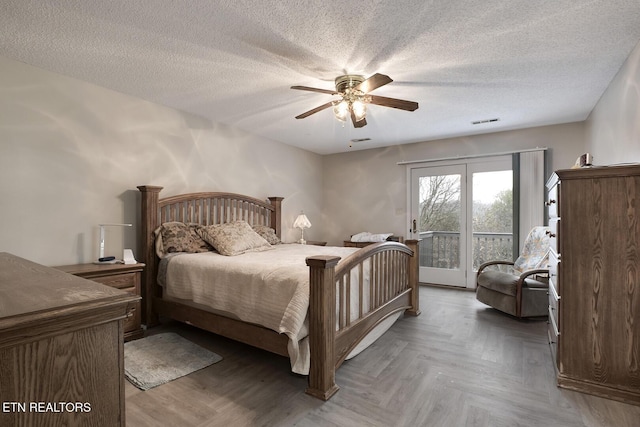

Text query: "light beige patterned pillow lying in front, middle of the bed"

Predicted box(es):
[198, 221, 272, 256]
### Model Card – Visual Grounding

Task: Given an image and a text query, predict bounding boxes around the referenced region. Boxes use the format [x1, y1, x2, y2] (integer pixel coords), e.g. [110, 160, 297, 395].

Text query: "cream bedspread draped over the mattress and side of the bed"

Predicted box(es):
[164, 244, 358, 375]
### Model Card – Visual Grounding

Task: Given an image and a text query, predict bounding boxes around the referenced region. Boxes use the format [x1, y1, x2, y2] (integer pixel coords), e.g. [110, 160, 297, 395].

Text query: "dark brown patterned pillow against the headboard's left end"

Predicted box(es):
[154, 221, 213, 258]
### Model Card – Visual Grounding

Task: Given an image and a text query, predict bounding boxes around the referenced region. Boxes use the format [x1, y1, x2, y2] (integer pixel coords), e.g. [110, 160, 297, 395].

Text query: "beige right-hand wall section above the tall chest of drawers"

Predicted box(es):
[586, 40, 640, 165]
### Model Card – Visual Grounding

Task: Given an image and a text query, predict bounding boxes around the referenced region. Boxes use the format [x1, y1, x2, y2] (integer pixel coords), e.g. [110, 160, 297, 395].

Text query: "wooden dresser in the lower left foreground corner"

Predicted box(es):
[0, 253, 140, 426]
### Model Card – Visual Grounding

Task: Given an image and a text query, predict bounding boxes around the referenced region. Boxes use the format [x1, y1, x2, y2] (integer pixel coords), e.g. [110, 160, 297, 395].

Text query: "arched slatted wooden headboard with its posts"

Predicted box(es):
[138, 185, 283, 326]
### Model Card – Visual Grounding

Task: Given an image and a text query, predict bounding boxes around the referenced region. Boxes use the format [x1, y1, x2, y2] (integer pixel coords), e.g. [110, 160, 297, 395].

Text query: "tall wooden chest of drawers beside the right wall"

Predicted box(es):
[546, 165, 640, 405]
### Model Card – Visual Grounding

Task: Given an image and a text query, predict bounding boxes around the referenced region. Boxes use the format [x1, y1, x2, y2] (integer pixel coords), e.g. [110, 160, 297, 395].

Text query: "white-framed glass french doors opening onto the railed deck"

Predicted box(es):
[409, 156, 514, 288]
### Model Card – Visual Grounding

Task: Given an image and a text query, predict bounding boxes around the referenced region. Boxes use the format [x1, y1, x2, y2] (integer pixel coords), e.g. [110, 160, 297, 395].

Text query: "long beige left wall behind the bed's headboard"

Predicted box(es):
[0, 57, 322, 265]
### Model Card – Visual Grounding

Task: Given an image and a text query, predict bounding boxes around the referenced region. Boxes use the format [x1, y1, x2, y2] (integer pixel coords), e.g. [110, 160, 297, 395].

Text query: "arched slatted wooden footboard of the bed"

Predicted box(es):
[307, 240, 420, 400]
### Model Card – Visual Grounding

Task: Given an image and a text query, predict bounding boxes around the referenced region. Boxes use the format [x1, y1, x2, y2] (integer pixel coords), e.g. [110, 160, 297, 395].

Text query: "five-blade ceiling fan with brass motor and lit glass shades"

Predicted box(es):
[291, 73, 418, 128]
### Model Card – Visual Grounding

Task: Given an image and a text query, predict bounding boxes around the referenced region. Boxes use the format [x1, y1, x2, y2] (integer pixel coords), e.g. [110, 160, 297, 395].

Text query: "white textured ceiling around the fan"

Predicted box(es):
[0, 0, 640, 154]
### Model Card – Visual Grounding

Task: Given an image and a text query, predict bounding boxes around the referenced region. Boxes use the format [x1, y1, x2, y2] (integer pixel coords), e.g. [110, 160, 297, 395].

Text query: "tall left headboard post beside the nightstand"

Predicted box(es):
[138, 185, 162, 327]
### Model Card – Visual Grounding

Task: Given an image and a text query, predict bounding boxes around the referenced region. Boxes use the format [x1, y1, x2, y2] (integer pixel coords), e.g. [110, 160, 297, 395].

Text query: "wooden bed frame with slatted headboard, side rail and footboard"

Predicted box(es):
[138, 185, 420, 400]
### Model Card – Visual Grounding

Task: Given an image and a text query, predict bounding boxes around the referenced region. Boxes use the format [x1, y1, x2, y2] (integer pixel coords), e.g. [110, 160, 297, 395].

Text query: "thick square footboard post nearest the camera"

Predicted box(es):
[306, 256, 340, 400]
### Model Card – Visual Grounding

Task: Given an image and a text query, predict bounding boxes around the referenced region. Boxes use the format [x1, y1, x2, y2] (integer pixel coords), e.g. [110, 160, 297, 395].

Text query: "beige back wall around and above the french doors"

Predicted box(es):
[323, 123, 585, 244]
